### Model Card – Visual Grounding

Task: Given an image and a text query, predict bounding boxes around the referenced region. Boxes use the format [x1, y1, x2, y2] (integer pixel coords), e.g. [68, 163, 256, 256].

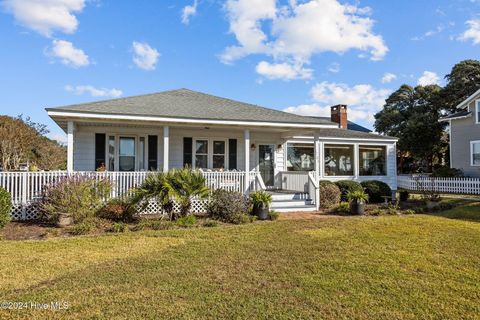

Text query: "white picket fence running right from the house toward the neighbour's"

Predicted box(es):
[398, 175, 480, 194]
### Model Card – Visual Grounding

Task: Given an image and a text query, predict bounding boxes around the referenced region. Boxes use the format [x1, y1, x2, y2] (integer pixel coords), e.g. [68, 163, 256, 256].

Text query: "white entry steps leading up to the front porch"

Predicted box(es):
[268, 190, 315, 212]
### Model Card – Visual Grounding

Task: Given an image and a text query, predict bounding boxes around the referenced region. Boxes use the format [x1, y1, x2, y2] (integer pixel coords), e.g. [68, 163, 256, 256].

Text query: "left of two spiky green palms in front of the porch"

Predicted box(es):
[130, 172, 175, 220]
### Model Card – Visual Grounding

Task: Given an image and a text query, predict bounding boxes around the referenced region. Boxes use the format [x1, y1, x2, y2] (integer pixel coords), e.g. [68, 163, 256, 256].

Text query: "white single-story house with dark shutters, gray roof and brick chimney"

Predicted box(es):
[46, 89, 397, 210]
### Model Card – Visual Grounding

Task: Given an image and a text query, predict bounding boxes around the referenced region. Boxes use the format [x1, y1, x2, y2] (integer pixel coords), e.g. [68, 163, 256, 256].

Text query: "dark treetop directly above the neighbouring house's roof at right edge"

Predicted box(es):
[440, 60, 480, 112]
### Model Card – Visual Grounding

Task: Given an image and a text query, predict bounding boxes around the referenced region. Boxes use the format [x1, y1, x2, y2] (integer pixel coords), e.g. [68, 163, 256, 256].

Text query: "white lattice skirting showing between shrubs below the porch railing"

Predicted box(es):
[11, 200, 208, 221]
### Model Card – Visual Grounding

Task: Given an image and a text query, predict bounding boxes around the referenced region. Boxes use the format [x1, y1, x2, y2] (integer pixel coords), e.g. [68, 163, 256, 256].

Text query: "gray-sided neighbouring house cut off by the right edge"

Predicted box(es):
[440, 90, 480, 177]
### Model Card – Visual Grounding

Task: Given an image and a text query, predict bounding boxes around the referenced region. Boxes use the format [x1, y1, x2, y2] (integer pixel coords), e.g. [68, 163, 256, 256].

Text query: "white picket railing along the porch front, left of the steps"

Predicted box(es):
[0, 171, 262, 220]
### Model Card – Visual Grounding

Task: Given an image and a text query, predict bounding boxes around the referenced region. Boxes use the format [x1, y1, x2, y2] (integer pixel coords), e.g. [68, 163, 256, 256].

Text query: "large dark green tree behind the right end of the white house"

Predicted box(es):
[374, 85, 446, 171]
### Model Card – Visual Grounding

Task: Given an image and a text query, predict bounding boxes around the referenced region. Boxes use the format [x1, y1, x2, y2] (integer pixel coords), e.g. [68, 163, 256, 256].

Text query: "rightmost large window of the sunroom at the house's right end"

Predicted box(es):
[359, 146, 387, 176]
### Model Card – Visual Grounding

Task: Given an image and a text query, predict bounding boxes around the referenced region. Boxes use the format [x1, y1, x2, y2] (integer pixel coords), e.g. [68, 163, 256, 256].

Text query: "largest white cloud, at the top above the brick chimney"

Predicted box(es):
[220, 0, 388, 79]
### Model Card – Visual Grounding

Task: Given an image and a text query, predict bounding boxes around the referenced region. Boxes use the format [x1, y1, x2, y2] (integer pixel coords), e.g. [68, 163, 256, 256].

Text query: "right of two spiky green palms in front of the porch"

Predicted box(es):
[168, 168, 210, 217]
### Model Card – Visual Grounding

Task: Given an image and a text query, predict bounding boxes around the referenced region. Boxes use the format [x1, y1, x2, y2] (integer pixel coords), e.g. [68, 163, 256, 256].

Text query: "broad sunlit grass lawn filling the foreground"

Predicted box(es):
[0, 203, 480, 319]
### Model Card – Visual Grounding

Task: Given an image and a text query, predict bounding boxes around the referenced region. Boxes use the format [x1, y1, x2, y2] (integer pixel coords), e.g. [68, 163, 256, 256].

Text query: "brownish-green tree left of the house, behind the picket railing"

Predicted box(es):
[0, 116, 66, 170]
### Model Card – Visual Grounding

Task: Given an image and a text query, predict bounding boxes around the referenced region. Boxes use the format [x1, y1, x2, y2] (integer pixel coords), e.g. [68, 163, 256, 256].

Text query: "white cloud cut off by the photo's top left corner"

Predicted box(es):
[2, 0, 85, 37]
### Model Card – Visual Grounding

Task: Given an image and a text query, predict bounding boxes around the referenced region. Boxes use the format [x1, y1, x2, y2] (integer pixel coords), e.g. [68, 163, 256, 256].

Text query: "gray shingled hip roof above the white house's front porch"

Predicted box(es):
[46, 89, 332, 125]
